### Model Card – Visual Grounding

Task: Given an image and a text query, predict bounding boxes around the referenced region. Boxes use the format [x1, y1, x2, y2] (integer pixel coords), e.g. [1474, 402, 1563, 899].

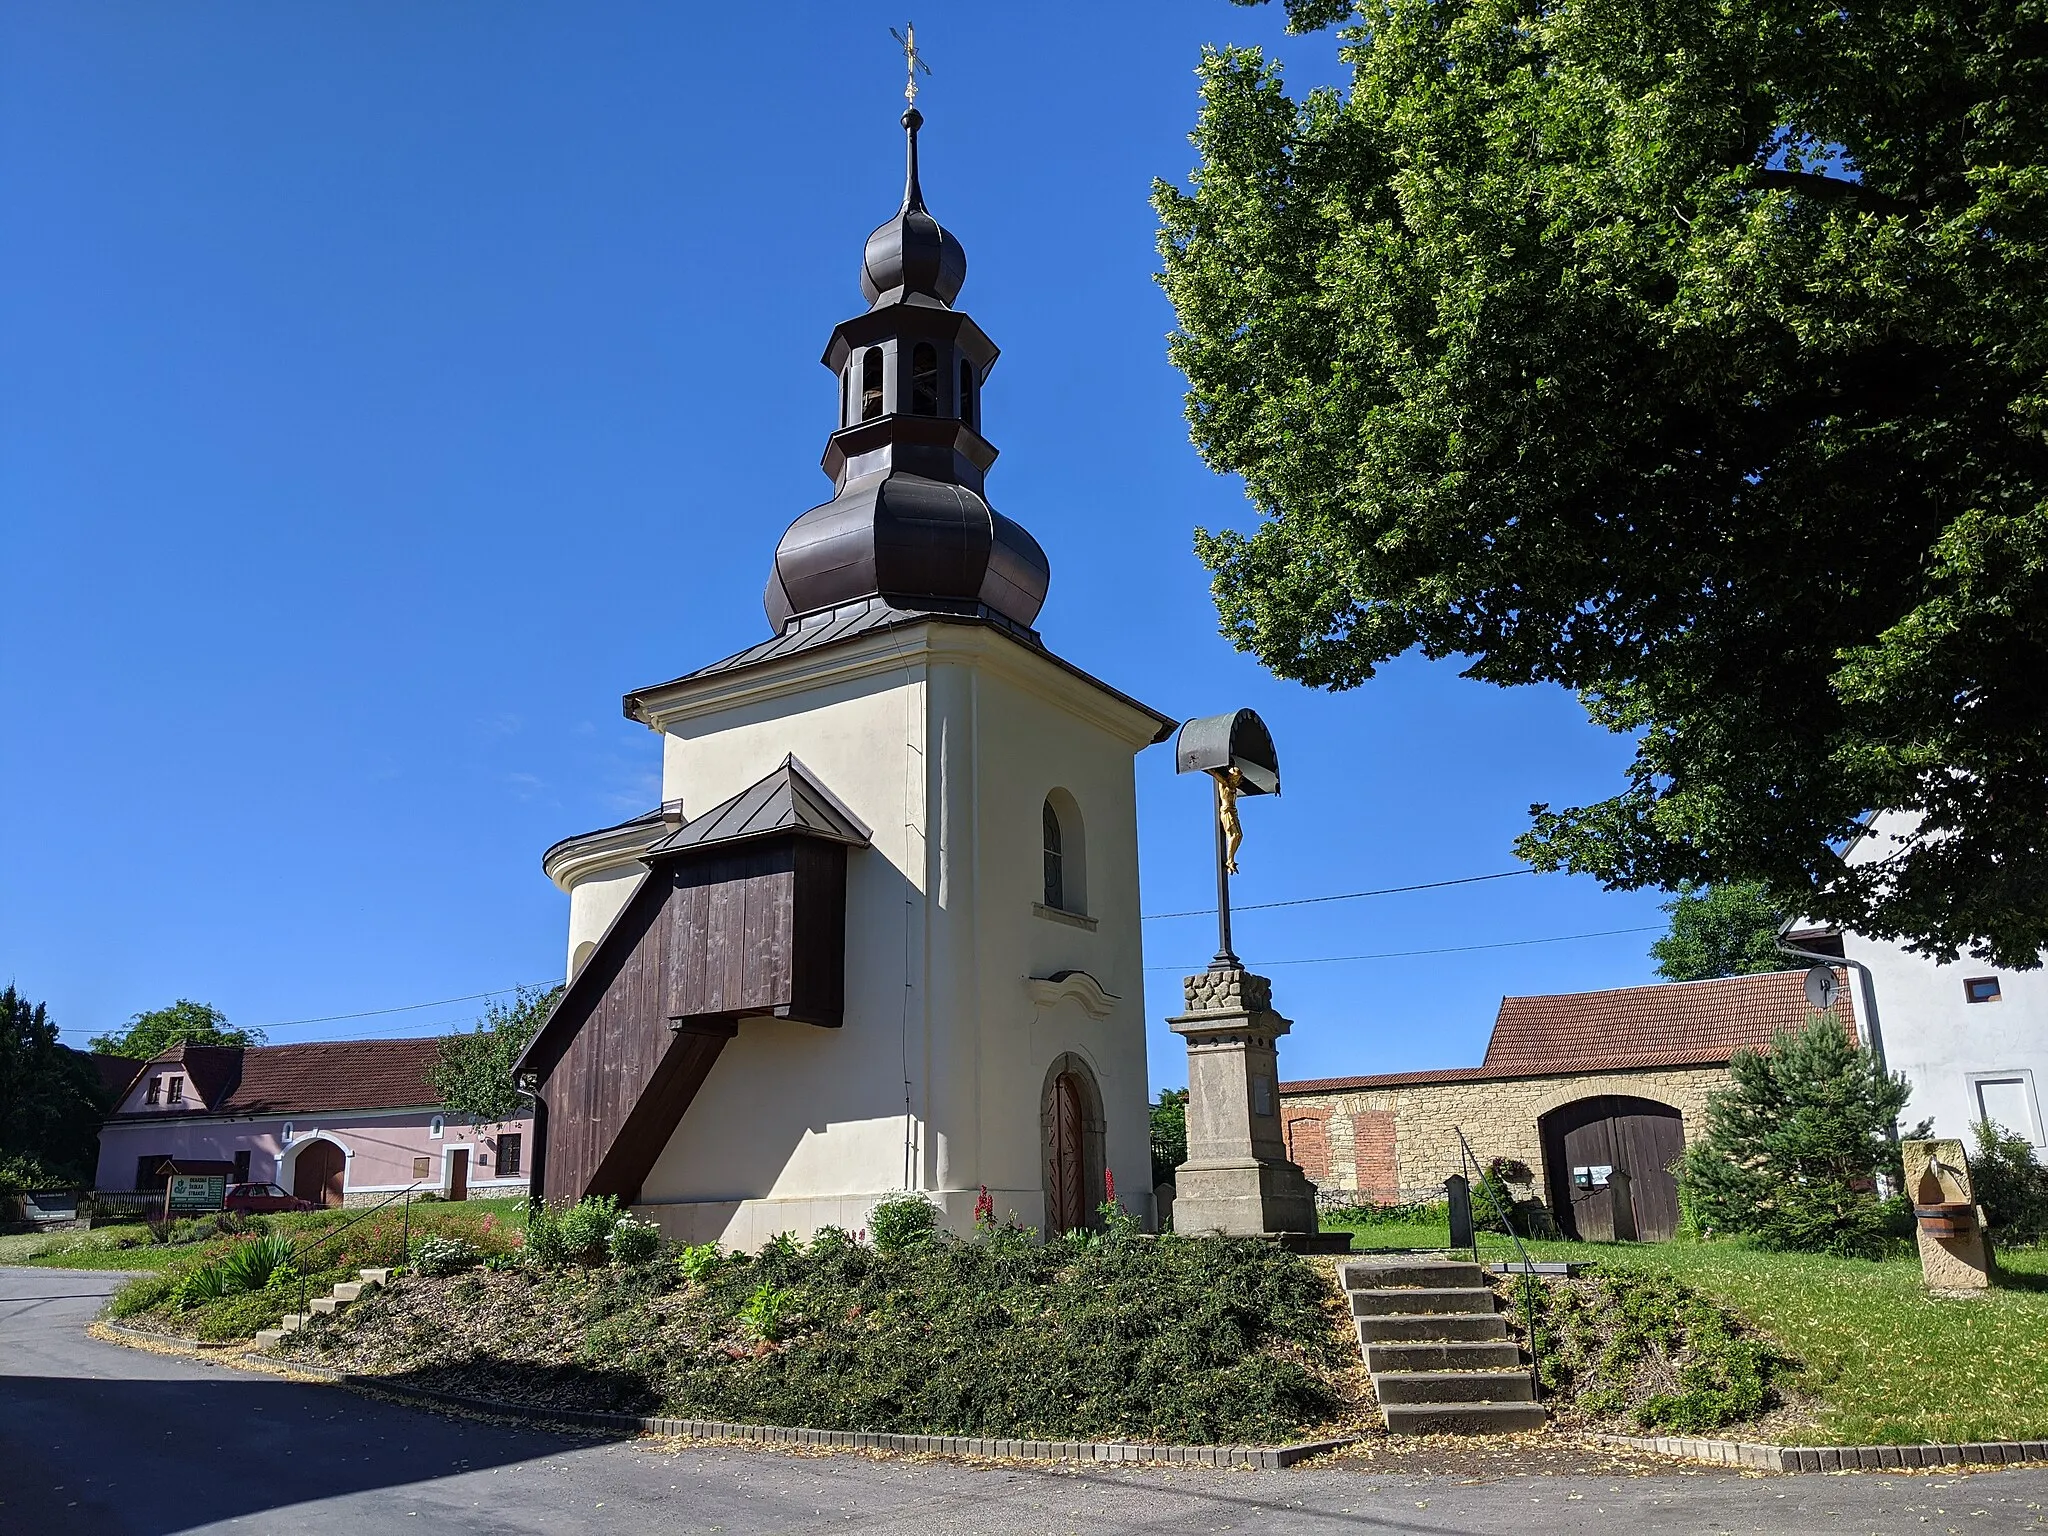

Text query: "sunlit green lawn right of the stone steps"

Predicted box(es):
[1318, 1223, 2048, 1446]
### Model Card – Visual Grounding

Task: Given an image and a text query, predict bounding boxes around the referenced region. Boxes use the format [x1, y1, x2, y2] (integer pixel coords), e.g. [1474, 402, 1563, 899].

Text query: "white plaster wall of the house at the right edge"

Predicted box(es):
[1843, 815, 2048, 1153]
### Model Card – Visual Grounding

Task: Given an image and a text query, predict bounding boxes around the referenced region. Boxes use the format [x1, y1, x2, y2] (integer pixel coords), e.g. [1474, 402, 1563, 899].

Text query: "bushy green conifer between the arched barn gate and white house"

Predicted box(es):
[1679, 1014, 1911, 1253]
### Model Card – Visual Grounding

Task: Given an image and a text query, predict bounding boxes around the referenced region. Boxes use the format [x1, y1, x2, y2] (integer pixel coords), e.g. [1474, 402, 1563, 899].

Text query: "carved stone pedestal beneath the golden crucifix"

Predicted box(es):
[1167, 967, 1317, 1237]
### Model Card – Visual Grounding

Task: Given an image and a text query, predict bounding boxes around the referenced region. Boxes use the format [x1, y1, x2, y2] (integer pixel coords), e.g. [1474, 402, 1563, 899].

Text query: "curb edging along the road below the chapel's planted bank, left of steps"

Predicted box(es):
[102, 1323, 1358, 1470]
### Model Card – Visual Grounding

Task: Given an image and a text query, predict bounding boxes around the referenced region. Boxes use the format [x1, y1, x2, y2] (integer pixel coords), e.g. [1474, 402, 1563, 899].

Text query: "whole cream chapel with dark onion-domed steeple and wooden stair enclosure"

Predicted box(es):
[518, 104, 1176, 1249]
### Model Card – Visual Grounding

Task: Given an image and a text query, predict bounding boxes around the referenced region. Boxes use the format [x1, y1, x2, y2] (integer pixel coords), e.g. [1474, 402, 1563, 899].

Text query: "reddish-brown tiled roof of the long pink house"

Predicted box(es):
[123, 1036, 440, 1120]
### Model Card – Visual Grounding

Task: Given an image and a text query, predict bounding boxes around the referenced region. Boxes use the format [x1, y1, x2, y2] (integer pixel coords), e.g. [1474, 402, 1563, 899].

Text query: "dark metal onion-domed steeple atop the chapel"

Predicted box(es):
[764, 106, 1053, 633]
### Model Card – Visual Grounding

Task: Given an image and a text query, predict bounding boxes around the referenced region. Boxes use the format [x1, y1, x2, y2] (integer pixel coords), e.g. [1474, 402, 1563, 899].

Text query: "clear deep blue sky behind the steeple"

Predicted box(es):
[0, 0, 1661, 1083]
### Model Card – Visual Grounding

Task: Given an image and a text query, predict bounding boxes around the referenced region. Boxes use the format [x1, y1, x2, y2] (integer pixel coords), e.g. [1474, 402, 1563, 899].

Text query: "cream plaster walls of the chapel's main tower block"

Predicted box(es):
[641, 625, 1153, 1247]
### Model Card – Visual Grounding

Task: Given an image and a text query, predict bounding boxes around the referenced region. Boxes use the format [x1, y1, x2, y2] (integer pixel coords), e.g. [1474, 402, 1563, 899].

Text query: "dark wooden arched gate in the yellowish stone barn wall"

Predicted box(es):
[1542, 1094, 1686, 1243]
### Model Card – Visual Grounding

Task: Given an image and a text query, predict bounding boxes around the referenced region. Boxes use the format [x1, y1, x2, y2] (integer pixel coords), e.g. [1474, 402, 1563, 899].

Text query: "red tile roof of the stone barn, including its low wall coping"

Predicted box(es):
[1280, 967, 1855, 1094]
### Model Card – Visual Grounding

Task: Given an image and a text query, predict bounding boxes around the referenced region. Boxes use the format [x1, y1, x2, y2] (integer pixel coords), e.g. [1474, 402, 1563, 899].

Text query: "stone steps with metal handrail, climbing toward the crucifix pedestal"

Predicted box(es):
[1337, 1260, 1548, 1434]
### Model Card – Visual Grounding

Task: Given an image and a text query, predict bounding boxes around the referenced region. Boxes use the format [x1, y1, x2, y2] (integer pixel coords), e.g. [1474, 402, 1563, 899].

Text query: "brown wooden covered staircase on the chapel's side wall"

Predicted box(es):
[516, 758, 868, 1202]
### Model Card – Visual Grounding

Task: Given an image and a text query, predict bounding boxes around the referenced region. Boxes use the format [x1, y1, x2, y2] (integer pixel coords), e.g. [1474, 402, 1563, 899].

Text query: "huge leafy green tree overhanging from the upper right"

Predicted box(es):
[1155, 0, 2048, 967]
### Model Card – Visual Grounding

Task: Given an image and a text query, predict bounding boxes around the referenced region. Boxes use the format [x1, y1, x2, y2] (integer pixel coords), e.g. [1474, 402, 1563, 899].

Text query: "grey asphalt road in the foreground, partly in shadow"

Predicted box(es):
[0, 1270, 2048, 1536]
